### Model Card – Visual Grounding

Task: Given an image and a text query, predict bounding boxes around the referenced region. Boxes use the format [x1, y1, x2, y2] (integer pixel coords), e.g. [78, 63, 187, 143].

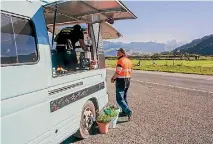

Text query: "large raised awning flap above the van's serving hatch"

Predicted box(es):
[43, 0, 137, 26]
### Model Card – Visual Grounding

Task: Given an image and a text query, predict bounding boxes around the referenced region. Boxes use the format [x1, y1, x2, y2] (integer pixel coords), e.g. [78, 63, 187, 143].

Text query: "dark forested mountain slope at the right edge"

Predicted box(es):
[172, 34, 213, 55]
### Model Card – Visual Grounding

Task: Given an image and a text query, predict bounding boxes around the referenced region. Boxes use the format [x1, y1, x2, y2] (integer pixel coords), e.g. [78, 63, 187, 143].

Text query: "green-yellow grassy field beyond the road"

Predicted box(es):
[105, 59, 213, 75]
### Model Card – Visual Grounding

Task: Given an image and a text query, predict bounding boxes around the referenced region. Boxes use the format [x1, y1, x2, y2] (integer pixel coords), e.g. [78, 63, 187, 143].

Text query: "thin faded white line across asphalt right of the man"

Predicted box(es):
[108, 76, 213, 94]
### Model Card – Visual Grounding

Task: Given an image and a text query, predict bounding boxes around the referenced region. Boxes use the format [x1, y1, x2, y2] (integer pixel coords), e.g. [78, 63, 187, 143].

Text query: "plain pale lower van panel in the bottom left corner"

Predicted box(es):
[1, 98, 51, 144]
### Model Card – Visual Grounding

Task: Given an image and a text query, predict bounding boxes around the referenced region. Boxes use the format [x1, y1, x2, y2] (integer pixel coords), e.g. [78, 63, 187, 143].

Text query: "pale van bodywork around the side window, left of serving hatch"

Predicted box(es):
[1, 1, 52, 144]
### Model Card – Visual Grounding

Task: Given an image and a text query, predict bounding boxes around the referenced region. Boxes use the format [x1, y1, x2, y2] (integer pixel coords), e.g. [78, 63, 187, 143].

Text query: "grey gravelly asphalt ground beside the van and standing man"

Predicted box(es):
[65, 70, 213, 144]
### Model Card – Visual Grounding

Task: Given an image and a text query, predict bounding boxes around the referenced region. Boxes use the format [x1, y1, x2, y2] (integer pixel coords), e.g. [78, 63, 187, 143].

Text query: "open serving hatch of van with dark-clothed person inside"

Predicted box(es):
[48, 25, 98, 76]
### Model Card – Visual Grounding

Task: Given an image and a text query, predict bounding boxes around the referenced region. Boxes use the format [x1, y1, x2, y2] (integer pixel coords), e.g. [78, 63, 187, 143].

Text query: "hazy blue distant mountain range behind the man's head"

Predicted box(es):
[104, 40, 184, 56]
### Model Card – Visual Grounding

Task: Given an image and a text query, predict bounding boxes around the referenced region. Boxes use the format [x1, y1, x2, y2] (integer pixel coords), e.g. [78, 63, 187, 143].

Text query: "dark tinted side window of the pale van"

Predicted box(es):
[1, 13, 38, 65]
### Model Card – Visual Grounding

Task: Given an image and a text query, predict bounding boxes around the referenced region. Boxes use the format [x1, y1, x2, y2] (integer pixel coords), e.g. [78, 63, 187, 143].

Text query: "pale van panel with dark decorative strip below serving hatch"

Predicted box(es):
[49, 70, 108, 143]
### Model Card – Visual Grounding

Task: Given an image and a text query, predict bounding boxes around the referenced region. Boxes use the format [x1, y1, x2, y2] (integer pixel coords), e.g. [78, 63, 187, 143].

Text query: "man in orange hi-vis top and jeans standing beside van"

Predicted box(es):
[111, 48, 132, 121]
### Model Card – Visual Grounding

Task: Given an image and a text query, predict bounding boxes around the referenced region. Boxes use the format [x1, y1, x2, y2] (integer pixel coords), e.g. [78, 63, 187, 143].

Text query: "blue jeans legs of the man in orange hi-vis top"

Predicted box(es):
[116, 88, 131, 116]
